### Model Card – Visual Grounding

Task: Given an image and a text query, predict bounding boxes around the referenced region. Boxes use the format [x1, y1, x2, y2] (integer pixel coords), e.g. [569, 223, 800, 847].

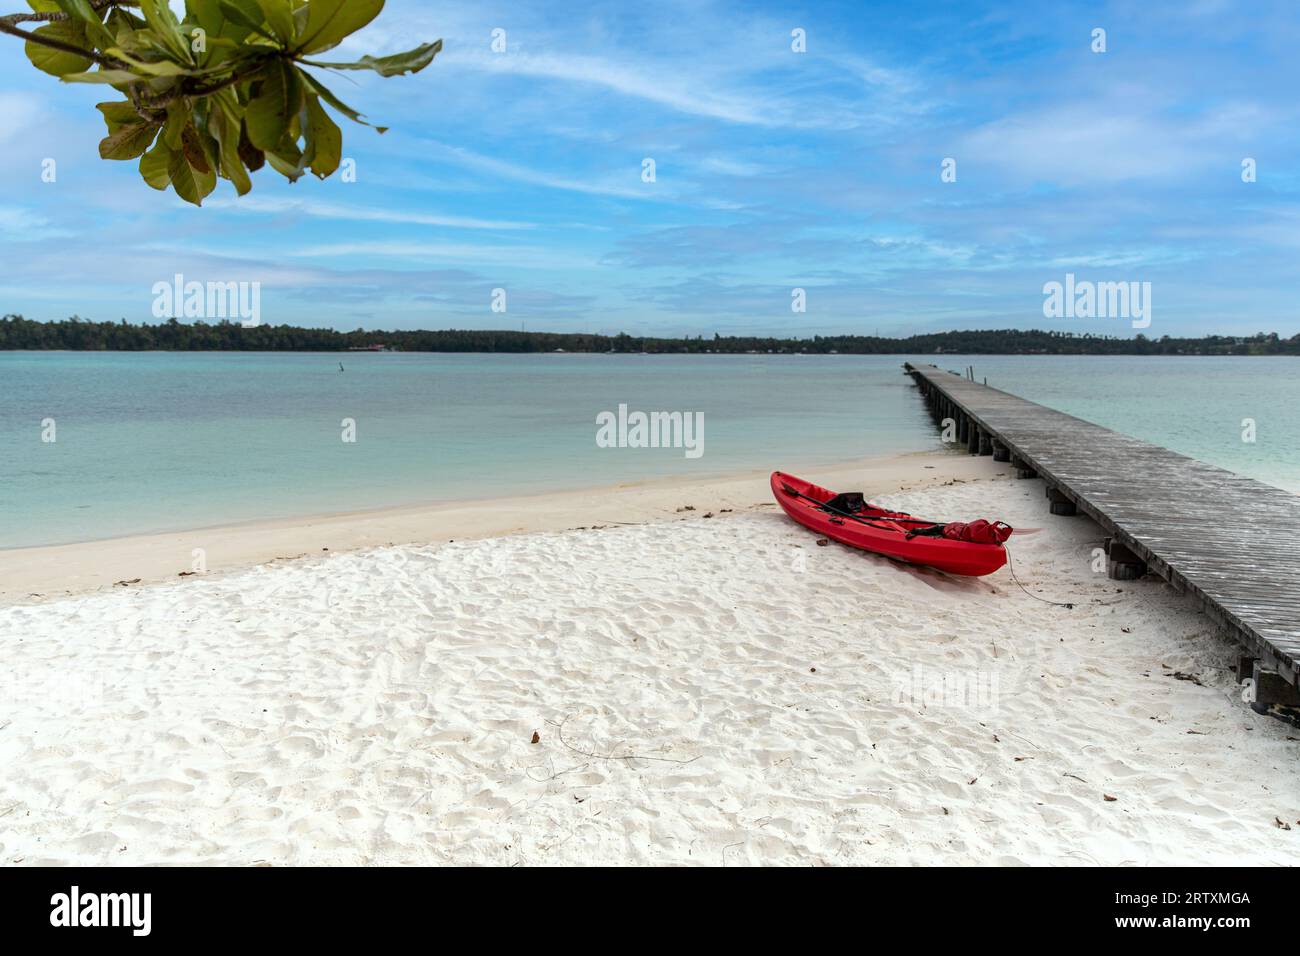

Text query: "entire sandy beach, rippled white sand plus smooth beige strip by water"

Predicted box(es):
[0, 455, 1300, 865]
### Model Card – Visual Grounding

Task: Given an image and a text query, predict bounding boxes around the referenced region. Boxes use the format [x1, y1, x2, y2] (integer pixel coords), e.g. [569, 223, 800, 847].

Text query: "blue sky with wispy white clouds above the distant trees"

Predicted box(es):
[0, 0, 1300, 336]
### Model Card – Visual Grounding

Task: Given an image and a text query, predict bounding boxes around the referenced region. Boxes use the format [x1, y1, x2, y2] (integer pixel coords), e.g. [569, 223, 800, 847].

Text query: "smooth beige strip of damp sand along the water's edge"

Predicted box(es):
[0, 451, 1009, 605]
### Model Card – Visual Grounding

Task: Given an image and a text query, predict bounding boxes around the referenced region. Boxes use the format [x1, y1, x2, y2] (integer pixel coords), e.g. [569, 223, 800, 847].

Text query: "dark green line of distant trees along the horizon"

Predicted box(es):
[0, 315, 1300, 355]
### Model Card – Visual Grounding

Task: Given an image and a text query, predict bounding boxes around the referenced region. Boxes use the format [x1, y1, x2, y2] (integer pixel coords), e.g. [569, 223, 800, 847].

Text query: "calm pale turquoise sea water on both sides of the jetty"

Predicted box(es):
[0, 352, 1300, 548]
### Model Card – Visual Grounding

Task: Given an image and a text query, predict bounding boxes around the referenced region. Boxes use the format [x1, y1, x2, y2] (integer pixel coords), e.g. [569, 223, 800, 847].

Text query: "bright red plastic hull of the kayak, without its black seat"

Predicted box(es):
[772, 471, 1006, 578]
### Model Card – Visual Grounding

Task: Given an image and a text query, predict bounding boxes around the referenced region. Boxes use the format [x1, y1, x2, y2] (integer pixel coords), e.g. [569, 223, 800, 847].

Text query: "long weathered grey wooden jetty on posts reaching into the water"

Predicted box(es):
[904, 363, 1300, 706]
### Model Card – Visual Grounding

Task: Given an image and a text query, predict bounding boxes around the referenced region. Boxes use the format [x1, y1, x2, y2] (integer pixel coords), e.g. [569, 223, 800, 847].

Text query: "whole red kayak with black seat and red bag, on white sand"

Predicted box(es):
[772, 471, 1011, 576]
